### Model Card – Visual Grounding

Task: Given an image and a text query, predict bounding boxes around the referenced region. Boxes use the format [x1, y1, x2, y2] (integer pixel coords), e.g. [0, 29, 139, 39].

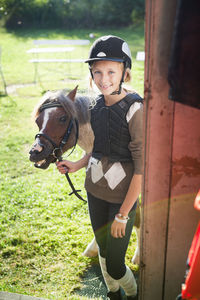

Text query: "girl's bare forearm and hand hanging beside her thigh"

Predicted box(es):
[111, 174, 142, 238]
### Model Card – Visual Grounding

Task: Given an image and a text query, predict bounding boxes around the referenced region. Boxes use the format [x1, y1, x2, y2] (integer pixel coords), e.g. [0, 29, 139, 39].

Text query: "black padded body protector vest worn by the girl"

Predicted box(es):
[91, 93, 143, 162]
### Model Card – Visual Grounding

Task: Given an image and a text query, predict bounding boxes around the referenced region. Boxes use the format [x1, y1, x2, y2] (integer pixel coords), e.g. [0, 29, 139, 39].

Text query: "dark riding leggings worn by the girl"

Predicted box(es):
[88, 193, 137, 280]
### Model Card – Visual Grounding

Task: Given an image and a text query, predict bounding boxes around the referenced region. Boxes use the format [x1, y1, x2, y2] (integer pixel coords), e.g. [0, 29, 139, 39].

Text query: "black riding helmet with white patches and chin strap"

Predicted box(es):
[85, 35, 132, 94]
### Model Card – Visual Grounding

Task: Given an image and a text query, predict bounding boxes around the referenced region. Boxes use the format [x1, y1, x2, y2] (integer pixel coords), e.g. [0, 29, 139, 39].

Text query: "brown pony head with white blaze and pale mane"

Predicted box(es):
[29, 87, 78, 169]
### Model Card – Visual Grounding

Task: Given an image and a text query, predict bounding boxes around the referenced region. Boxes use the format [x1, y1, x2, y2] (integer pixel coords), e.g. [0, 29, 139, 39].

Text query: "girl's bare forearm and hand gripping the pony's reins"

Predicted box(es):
[56, 153, 91, 174]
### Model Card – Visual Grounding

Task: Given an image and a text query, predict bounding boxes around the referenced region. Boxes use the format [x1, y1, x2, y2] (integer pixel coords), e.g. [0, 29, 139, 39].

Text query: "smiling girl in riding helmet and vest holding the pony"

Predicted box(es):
[57, 36, 143, 300]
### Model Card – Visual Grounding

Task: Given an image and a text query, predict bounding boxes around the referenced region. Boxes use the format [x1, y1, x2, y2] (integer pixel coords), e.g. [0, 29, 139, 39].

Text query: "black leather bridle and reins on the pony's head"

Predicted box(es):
[35, 102, 86, 202]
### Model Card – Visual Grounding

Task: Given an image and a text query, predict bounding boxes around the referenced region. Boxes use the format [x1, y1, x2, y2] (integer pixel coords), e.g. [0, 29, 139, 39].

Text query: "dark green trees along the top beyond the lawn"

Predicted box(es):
[0, 0, 144, 28]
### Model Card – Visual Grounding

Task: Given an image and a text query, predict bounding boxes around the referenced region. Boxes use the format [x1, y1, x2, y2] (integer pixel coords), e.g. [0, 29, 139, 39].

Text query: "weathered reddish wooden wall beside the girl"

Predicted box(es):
[139, 0, 200, 300]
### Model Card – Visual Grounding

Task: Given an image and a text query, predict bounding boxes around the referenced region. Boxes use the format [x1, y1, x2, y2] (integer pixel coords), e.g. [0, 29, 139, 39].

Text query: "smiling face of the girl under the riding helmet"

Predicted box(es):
[92, 60, 123, 96]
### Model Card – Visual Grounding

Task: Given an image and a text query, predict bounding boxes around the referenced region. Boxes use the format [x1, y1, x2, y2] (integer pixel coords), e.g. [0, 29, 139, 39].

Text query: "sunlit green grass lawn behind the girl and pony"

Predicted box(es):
[0, 28, 144, 300]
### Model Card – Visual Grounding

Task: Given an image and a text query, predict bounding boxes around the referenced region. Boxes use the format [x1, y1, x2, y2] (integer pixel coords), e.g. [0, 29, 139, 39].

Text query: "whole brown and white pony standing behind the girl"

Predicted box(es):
[29, 87, 140, 263]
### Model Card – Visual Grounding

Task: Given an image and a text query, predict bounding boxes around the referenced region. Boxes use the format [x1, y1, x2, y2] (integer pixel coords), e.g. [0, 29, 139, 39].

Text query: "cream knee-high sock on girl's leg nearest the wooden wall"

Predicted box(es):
[117, 266, 137, 300]
